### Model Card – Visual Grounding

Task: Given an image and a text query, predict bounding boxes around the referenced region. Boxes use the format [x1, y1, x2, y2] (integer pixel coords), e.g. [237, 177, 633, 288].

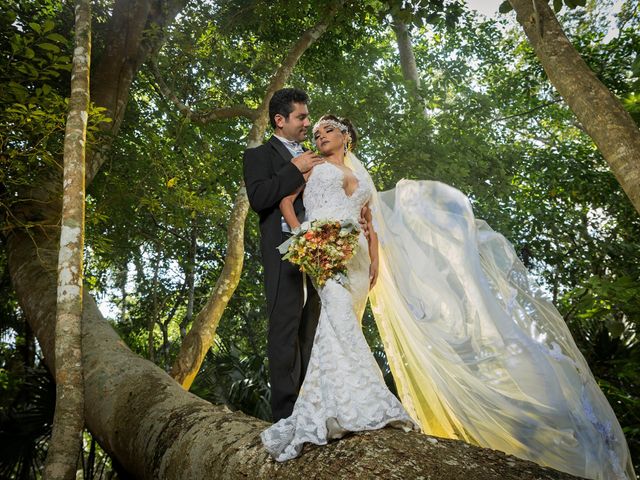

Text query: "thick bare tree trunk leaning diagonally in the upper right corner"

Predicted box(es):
[509, 0, 640, 216]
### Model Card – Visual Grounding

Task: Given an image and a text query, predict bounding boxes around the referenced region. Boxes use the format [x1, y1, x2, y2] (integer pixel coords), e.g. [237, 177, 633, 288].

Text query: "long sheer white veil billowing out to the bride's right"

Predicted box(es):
[346, 153, 636, 480]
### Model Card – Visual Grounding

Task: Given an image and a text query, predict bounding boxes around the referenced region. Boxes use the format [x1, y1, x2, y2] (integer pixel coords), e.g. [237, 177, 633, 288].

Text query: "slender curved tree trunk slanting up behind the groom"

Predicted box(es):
[169, 0, 344, 390]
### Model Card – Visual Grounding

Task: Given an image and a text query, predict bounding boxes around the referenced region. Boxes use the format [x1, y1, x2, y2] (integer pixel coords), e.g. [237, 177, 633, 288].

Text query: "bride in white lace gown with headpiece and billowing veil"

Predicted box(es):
[262, 116, 636, 480]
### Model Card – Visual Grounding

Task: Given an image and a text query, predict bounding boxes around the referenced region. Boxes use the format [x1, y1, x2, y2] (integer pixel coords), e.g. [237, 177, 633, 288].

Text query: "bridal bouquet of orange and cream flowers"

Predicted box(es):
[278, 220, 360, 286]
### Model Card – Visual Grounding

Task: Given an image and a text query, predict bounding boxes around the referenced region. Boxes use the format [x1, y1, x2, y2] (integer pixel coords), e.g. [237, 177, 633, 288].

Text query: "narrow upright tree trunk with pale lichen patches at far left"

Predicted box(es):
[44, 0, 91, 480]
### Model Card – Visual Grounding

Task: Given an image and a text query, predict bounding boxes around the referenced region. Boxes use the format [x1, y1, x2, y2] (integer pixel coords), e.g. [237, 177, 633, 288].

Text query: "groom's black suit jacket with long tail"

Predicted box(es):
[244, 137, 304, 315]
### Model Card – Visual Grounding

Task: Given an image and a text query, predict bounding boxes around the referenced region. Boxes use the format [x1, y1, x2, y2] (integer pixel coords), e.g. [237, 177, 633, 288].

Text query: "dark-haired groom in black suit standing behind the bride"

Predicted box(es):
[244, 88, 323, 422]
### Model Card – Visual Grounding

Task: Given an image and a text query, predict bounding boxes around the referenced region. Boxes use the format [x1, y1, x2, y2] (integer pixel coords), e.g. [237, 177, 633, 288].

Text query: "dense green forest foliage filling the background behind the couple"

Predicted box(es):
[0, 0, 640, 478]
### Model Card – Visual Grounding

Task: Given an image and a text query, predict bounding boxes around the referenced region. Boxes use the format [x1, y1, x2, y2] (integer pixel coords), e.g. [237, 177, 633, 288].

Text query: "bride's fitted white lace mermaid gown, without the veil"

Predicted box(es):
[261, 162, 418, 461]
